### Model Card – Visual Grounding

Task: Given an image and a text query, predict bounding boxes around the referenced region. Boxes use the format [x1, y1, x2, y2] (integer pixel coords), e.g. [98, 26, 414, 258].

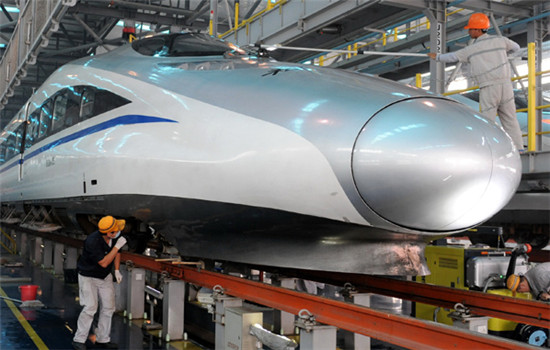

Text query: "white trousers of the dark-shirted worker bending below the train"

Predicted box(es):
[73, 274, 115, 343]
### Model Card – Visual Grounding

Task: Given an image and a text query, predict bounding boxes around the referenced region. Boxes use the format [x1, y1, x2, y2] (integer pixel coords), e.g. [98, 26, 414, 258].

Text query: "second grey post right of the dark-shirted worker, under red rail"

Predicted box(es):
[162, 280, 185, 341]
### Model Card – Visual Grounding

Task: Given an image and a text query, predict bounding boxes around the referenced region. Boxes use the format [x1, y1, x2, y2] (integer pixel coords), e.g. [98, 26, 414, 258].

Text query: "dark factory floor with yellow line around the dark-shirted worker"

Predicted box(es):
[0, 250, 203, 350]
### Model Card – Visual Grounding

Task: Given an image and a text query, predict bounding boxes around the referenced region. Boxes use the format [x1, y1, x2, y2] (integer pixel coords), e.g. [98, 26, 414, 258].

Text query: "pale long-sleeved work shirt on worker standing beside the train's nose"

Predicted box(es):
[436, 34, 519, 87]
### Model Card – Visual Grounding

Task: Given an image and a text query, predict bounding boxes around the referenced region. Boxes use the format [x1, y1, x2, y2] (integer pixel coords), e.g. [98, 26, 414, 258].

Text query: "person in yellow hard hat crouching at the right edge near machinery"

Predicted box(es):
[506, 262, 550, 301]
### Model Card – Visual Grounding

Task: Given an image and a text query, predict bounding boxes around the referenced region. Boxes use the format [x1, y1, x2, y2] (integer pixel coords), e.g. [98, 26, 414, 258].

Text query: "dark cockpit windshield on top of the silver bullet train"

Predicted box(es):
[132, 33, 248, 57]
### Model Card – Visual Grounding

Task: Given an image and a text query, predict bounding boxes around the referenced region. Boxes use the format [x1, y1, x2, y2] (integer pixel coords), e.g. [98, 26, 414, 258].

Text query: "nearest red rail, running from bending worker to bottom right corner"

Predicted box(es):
[122, 252, 544, 349]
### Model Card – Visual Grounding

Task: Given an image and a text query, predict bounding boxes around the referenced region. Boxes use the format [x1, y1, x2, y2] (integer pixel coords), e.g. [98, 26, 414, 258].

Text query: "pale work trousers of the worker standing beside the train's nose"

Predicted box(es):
[479, 83, 523, 150]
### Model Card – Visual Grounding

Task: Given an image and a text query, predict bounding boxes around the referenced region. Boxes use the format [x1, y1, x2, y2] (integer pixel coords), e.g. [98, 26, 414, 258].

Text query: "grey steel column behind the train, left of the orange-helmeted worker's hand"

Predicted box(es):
[424, 0, 447, 94]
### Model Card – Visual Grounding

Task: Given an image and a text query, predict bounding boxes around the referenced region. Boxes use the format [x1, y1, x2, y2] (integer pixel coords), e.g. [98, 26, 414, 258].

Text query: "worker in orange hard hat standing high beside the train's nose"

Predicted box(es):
[428, 13, 524, 152]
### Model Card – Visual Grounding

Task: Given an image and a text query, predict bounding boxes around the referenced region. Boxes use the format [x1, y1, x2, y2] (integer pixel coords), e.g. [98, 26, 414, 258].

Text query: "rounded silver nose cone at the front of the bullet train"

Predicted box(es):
[352, 98, 521, 231]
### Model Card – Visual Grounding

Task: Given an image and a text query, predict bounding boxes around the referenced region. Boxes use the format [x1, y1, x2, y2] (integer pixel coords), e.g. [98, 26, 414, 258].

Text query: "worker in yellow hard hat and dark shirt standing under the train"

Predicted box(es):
[72, 216, 126, 350]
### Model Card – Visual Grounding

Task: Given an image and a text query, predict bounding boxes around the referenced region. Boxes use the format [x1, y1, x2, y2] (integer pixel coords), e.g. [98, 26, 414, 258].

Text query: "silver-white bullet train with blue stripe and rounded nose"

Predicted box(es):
[0, 33, 521, 275]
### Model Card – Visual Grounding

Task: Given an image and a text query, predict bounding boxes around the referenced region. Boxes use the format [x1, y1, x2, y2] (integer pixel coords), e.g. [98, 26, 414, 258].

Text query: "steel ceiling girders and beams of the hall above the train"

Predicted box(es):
[0, 0, 550, 126]
